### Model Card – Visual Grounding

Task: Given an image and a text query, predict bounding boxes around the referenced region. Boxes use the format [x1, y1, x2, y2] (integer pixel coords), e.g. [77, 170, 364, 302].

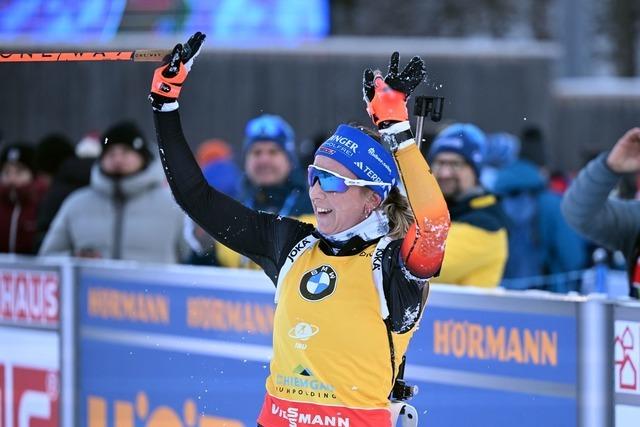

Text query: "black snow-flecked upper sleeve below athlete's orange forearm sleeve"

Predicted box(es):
[382, 240, 428, 333]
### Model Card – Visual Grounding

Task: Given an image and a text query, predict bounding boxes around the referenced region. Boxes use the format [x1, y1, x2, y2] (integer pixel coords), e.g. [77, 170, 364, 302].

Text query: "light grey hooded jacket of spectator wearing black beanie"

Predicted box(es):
[40, 161, 188, 263]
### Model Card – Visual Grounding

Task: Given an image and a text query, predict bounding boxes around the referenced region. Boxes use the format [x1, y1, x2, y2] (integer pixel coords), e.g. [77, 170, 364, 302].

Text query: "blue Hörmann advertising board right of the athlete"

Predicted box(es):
[405, 287, 578, 427]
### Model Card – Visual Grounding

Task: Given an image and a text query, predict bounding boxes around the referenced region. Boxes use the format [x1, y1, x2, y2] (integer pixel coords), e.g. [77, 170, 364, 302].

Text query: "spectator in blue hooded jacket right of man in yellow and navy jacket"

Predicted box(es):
[494, 142, 587, 292]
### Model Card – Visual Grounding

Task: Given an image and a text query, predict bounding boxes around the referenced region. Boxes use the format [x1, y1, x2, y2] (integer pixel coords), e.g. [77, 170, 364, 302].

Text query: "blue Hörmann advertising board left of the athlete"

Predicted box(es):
[78, 268, 274, 427]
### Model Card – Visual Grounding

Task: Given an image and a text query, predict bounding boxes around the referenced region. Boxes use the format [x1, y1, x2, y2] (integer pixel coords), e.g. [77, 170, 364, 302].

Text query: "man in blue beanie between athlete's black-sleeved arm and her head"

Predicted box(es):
[216, 114, 314, 268]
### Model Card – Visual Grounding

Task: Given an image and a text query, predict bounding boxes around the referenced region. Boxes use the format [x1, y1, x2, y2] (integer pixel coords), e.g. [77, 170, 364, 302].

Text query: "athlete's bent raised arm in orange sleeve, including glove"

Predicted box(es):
[363, 52, 450, 278]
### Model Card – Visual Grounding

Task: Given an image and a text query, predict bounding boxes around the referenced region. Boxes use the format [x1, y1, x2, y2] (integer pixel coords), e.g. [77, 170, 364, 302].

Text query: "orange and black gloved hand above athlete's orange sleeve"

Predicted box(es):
[362, 52, 427, 128]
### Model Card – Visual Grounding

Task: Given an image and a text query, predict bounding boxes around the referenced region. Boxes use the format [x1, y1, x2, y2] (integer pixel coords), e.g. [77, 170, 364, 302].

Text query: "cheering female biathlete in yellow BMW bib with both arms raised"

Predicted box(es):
[149, 33, 449, 427]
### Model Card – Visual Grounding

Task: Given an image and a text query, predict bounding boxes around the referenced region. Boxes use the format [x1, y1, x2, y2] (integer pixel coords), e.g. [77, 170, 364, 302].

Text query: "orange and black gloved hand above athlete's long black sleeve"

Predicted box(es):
[149, 31, 206, 111]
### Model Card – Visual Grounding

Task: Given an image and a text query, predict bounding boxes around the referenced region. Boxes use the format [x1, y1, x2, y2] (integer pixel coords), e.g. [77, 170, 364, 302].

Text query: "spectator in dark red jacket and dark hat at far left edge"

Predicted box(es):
[0, 143, 46, 254]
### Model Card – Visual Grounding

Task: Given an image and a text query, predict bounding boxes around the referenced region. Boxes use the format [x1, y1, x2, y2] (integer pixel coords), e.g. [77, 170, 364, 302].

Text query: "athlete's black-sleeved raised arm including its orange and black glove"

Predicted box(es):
[149, 33, 313, 280]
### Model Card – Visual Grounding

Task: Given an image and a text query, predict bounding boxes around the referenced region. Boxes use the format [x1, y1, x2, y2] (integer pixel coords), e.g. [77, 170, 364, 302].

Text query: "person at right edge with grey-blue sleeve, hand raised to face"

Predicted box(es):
[562, 127, 640, 298]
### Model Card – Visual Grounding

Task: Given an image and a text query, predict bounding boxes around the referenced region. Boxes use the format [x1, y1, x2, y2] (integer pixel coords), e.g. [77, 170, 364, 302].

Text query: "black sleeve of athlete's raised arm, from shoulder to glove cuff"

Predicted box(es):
[154, 111, 314, 284]
